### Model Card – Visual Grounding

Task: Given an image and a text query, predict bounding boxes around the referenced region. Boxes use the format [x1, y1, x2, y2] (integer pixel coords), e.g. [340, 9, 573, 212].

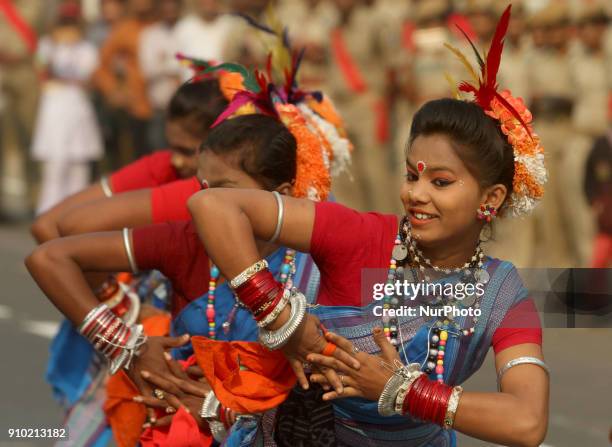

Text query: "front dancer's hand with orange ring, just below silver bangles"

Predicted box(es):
[282, 315, 360, 394]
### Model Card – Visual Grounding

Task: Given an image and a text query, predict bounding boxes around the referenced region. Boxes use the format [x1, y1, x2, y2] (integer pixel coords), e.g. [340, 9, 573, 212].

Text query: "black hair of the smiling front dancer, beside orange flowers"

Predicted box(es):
[408, 98, 514, 210]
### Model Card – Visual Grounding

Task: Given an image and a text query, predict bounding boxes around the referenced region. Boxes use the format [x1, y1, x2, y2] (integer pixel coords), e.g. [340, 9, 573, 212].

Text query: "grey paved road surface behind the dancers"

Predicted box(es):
[0, 225, 612, 447]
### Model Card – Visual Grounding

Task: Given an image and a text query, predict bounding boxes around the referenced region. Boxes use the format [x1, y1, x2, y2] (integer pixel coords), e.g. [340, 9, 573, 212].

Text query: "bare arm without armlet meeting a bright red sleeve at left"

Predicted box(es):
[57, 189, 152, 236]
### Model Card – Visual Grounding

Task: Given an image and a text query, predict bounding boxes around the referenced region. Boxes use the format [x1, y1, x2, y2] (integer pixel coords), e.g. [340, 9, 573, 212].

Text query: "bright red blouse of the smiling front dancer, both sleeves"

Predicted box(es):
[310, 202, 542, 353]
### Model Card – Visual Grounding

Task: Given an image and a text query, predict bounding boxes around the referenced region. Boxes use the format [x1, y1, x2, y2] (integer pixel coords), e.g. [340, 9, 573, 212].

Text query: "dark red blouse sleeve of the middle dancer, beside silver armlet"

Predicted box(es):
[132, 220, 210, 316]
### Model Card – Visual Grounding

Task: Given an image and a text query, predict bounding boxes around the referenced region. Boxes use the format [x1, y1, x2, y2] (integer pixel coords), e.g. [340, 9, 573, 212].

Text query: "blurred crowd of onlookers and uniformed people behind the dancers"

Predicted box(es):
[0, 0, 612, 267]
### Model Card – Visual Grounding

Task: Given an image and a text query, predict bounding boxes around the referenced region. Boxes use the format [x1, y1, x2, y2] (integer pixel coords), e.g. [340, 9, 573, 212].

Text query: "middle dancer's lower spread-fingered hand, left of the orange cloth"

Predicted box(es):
[134, 353, 210, 429]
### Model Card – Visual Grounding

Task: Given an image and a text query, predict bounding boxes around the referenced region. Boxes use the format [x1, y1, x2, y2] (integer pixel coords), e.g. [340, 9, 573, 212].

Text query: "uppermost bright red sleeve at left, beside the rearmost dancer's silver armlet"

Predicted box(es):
[109, 150, 179, 193]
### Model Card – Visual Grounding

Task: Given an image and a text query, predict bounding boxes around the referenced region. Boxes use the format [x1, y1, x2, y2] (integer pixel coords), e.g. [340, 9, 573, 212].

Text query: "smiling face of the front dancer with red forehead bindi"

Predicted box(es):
[401, 133, 505, 247]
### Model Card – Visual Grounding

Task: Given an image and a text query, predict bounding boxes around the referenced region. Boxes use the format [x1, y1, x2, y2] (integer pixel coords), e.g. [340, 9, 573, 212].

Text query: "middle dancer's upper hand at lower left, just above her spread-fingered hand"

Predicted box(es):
[127, 334, 189, 428]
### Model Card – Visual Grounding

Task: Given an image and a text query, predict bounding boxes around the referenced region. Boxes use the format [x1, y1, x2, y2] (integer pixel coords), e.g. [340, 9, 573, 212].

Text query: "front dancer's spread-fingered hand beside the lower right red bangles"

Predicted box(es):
[307, 328, 400, 400]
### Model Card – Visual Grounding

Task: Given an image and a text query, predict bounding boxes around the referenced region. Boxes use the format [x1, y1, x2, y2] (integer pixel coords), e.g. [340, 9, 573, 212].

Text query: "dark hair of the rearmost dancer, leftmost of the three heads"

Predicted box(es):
[168, 79, 228, 139]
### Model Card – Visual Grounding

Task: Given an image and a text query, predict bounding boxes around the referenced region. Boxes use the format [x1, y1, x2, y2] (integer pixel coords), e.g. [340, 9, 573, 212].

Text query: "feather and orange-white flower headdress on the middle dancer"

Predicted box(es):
[204, 14, 352, 200]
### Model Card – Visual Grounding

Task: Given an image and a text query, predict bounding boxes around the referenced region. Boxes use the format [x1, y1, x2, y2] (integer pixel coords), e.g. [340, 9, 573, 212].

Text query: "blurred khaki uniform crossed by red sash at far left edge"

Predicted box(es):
[0, 0, 45, 214]
